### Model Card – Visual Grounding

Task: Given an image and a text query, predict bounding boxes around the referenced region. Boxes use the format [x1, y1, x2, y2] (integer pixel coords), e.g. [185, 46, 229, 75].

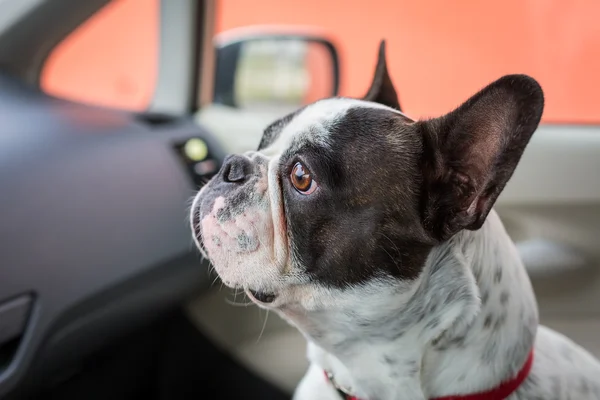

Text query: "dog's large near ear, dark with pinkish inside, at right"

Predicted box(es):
[417, 75, 544, 240]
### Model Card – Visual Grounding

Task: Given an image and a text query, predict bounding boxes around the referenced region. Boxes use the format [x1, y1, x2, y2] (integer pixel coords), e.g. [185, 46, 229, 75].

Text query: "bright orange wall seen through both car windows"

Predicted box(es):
[42, 0, 600, 123]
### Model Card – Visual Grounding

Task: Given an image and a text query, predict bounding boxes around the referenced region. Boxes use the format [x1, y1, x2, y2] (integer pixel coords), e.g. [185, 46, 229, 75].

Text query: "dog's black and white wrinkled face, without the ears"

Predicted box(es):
[195, 99, 428, 306]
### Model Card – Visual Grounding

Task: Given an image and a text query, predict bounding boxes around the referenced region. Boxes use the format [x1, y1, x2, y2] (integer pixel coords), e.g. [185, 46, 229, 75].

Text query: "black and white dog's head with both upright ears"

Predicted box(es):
[191, 43, 543, 311]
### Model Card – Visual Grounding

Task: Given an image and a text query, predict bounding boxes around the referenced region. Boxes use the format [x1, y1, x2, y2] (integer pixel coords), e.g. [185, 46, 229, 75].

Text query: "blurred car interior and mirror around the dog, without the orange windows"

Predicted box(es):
[0, 0, 600, 399]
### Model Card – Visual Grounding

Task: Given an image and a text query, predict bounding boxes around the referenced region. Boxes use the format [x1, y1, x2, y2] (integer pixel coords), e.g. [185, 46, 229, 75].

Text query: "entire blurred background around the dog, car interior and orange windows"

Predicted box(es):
[0, 0, 600, 399]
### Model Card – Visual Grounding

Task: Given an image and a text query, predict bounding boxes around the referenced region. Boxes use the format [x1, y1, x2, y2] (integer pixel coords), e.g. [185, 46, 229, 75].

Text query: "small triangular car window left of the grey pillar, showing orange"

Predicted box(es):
[40, 0, 159, 111]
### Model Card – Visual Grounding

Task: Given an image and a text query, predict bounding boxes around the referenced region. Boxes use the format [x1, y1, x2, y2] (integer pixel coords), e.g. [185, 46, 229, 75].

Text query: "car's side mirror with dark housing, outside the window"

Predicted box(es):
[213, 29, 340, 112]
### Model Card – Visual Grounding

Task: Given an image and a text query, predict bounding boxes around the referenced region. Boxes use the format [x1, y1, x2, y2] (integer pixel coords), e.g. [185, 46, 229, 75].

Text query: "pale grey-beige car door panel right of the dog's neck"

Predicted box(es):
[496, 126, 600, 356]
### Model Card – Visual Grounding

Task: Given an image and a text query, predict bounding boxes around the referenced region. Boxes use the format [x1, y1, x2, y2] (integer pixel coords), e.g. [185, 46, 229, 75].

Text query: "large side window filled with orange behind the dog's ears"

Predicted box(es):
[217, 0, 600, 124]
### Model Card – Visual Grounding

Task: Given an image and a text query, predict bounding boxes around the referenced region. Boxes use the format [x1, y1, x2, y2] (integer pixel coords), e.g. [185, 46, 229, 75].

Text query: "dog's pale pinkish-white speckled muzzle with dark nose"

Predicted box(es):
[191, 153, 282, 294]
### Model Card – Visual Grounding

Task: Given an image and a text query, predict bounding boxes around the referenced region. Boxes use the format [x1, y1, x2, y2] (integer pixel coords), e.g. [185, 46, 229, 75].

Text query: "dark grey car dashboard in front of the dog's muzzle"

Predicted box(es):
[0, 75, 224, 397]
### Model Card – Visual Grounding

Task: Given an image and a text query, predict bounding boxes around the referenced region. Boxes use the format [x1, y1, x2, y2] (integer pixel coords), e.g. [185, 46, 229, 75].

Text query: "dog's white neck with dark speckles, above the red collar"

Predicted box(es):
[287, 211, 538, 399]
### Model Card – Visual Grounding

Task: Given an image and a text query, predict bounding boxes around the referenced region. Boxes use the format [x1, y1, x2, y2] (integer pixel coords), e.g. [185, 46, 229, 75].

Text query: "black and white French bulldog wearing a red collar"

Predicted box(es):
[191, 41, 600, 400]
